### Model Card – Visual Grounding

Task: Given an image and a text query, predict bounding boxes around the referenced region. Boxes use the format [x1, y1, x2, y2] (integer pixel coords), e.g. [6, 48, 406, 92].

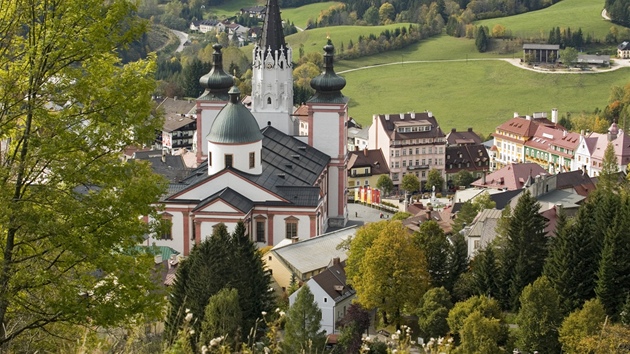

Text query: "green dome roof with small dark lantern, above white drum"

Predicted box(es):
[206, 87, 263, 144]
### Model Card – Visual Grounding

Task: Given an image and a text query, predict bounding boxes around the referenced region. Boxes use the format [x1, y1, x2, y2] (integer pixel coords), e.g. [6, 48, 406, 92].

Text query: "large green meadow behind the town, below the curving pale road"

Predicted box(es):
[343, 60, 630, 134]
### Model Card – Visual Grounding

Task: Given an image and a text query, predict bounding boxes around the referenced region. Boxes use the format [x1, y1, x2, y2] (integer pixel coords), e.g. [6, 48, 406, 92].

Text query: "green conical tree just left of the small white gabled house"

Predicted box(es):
[282, 284, 326, 353]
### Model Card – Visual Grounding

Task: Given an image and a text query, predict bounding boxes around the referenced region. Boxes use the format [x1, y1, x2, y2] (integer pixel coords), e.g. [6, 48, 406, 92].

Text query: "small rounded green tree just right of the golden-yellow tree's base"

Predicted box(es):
[418, 287, 453, 338]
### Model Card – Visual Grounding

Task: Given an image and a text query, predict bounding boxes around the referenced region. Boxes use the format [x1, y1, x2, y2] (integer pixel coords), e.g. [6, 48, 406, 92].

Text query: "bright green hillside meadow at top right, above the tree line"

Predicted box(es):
[475, 0, 623, 39]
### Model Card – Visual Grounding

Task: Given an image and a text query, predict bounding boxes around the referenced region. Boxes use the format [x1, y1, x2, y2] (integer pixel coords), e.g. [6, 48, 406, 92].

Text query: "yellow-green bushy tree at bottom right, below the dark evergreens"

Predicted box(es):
[559, 299, 606, 354]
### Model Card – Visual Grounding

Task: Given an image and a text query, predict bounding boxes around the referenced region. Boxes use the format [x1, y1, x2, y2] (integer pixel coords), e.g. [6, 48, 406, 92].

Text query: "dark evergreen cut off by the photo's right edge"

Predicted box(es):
[595, 195, 630, 320]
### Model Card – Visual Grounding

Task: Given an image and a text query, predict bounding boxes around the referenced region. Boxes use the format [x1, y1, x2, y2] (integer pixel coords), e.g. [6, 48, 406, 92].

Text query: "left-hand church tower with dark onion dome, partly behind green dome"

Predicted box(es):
[195, 44, 234, 163]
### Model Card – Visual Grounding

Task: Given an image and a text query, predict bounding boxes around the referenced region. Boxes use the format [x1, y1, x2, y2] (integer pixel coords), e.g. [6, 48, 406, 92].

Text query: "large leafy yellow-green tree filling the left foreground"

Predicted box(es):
[0, 0, 165, 352]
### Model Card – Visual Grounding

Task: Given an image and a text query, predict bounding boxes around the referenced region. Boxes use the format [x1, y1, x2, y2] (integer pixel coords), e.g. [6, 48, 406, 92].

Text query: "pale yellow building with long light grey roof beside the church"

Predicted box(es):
[263, 226, 358, 294]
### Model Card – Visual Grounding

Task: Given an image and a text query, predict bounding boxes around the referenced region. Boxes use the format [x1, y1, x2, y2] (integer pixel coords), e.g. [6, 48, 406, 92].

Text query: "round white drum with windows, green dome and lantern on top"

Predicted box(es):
[206, 87, 263, 175]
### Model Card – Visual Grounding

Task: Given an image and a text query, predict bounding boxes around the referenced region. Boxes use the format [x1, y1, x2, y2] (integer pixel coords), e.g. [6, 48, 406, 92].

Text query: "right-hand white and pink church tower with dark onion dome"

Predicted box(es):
[306, 40, 348, 227]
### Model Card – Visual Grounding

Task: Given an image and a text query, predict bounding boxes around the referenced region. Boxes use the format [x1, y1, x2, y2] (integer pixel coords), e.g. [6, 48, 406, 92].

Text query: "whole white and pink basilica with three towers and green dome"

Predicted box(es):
[147, 0, 348, 255]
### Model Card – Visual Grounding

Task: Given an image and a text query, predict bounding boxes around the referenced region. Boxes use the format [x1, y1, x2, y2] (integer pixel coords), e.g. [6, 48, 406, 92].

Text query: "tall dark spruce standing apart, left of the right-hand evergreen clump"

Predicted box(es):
[501, 190, 547, 309]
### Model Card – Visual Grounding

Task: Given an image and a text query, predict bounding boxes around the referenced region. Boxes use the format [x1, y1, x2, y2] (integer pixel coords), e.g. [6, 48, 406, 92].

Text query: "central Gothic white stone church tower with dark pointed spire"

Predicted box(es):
[252, 0, 297, 135]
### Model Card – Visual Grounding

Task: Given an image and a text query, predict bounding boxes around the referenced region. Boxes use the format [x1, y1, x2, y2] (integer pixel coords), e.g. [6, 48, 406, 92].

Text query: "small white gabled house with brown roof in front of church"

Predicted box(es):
[289, 258, 356, 334]
